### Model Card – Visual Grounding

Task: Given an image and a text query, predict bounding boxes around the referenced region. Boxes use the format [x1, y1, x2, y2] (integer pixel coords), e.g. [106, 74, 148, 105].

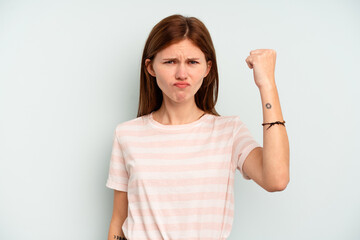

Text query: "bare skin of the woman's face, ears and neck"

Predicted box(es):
[145, 39, 211, 125]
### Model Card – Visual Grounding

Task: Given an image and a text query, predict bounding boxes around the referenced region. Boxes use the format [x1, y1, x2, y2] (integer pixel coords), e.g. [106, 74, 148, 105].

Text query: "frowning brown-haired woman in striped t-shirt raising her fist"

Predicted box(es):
[106, 15, 289, 240]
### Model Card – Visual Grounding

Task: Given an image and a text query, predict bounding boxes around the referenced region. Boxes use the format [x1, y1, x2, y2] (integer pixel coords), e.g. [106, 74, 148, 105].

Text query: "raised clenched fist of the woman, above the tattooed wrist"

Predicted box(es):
[245, 49, 276, 89]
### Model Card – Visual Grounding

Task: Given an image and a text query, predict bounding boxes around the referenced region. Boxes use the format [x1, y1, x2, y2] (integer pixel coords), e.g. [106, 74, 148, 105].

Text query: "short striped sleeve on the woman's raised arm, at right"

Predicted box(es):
[232, 116, 261, 180]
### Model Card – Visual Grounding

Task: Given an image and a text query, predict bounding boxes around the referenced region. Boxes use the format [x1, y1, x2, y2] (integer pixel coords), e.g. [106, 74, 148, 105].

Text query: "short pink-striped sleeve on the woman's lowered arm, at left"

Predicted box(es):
[106, 127, 129, 192]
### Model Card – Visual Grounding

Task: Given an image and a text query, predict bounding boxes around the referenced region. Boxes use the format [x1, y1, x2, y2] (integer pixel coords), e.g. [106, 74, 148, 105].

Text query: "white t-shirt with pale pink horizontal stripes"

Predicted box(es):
[106, 113, 261, 240]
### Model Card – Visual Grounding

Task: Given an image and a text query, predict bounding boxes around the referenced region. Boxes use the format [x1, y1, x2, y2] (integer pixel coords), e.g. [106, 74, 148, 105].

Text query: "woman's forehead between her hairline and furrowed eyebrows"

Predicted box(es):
[157, 39, 205, 57]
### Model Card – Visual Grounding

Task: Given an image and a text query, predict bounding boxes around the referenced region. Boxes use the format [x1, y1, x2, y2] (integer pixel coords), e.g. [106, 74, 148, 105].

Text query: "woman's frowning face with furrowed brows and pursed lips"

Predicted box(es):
[145, 39, 211, 102]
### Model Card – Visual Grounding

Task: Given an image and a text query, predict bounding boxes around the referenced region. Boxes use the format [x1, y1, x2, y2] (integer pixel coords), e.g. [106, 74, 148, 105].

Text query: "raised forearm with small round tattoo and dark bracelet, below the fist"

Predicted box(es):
[259, 81, 290, 190]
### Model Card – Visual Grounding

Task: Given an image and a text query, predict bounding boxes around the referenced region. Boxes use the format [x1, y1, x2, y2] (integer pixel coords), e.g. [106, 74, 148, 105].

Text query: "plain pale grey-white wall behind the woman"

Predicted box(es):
[0, 0, 360, 240]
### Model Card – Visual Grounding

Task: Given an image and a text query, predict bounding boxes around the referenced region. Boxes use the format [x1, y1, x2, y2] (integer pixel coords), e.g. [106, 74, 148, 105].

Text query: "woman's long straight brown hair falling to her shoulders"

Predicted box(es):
[137, 14, 220, 117]
